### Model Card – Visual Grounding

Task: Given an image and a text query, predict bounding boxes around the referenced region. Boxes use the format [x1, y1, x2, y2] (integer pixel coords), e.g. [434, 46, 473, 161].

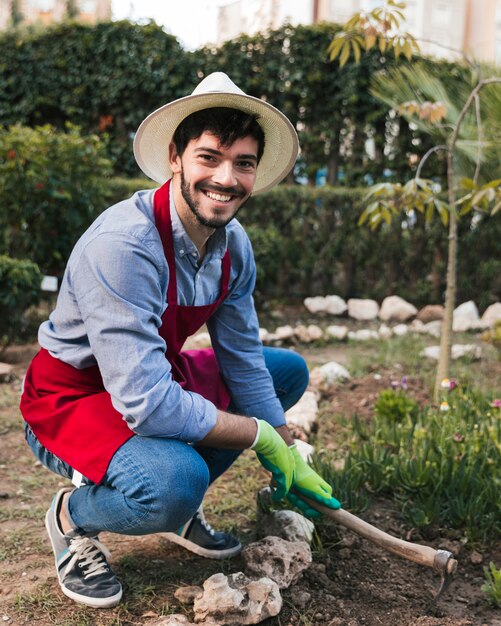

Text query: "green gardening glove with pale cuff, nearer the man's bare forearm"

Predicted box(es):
[251, 418, 295, 501]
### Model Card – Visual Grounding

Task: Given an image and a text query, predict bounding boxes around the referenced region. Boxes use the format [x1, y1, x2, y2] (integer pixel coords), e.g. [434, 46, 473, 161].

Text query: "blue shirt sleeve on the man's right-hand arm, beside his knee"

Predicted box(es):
[207, 235, 285, 427]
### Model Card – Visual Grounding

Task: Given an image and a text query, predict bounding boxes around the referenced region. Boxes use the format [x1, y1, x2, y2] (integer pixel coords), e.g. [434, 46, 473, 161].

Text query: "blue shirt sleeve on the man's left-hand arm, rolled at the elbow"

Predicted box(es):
[71, 233, 217, 441]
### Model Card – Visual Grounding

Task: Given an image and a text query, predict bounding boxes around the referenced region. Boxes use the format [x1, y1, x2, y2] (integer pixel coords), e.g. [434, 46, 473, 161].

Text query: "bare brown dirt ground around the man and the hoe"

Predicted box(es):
[0, 346, 501, 626]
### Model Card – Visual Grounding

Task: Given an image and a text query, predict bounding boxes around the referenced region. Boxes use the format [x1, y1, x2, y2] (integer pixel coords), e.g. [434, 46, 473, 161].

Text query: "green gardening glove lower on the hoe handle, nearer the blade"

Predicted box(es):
[287, 444, 341, 517]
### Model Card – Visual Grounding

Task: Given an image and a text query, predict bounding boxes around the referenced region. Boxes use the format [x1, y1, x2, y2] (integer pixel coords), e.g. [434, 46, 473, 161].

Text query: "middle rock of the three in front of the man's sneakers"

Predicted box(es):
[242, 536, 312, 589]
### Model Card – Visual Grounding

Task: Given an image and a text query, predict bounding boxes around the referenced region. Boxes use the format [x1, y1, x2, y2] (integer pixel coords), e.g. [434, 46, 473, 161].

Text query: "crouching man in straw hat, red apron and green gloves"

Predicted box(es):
[21, 73, 340, 607]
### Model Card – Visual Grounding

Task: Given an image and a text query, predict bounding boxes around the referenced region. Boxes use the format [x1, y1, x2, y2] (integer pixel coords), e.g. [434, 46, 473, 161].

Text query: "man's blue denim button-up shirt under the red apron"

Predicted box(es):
[38, 185, 285, 441]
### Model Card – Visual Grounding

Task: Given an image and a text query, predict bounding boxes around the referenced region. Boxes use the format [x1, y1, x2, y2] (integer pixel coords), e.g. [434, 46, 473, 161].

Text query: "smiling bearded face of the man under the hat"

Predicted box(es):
[170, 132, 258, 228]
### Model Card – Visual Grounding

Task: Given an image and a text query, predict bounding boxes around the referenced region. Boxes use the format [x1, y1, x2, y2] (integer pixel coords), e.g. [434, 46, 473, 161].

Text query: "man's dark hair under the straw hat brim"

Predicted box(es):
[172, 107, 264, 162]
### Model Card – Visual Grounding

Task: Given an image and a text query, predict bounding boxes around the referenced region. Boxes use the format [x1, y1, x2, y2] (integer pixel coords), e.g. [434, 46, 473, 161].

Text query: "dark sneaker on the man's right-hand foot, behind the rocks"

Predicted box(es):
[162, 508, 242, 559]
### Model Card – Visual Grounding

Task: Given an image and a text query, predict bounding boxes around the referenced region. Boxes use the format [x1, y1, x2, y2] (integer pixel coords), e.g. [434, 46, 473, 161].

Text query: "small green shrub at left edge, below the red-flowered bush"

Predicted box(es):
[0, 255, 42, 349]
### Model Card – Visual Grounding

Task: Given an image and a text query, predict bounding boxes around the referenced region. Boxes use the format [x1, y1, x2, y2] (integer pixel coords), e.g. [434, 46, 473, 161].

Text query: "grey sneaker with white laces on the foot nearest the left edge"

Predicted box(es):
[45, 488, 122, 608]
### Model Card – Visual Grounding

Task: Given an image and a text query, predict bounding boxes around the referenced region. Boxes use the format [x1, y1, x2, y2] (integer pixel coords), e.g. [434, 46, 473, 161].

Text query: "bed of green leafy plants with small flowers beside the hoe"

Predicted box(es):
[319, 387, 501, 543]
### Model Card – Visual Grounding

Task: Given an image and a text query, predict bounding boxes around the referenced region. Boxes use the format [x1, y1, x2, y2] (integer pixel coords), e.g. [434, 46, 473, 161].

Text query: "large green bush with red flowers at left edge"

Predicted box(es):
[0, 126, 111, 274]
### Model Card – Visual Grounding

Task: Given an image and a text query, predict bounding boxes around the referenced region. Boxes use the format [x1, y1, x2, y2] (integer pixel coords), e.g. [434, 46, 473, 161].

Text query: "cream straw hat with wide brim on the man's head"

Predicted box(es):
[134, 72, 299, 194]
